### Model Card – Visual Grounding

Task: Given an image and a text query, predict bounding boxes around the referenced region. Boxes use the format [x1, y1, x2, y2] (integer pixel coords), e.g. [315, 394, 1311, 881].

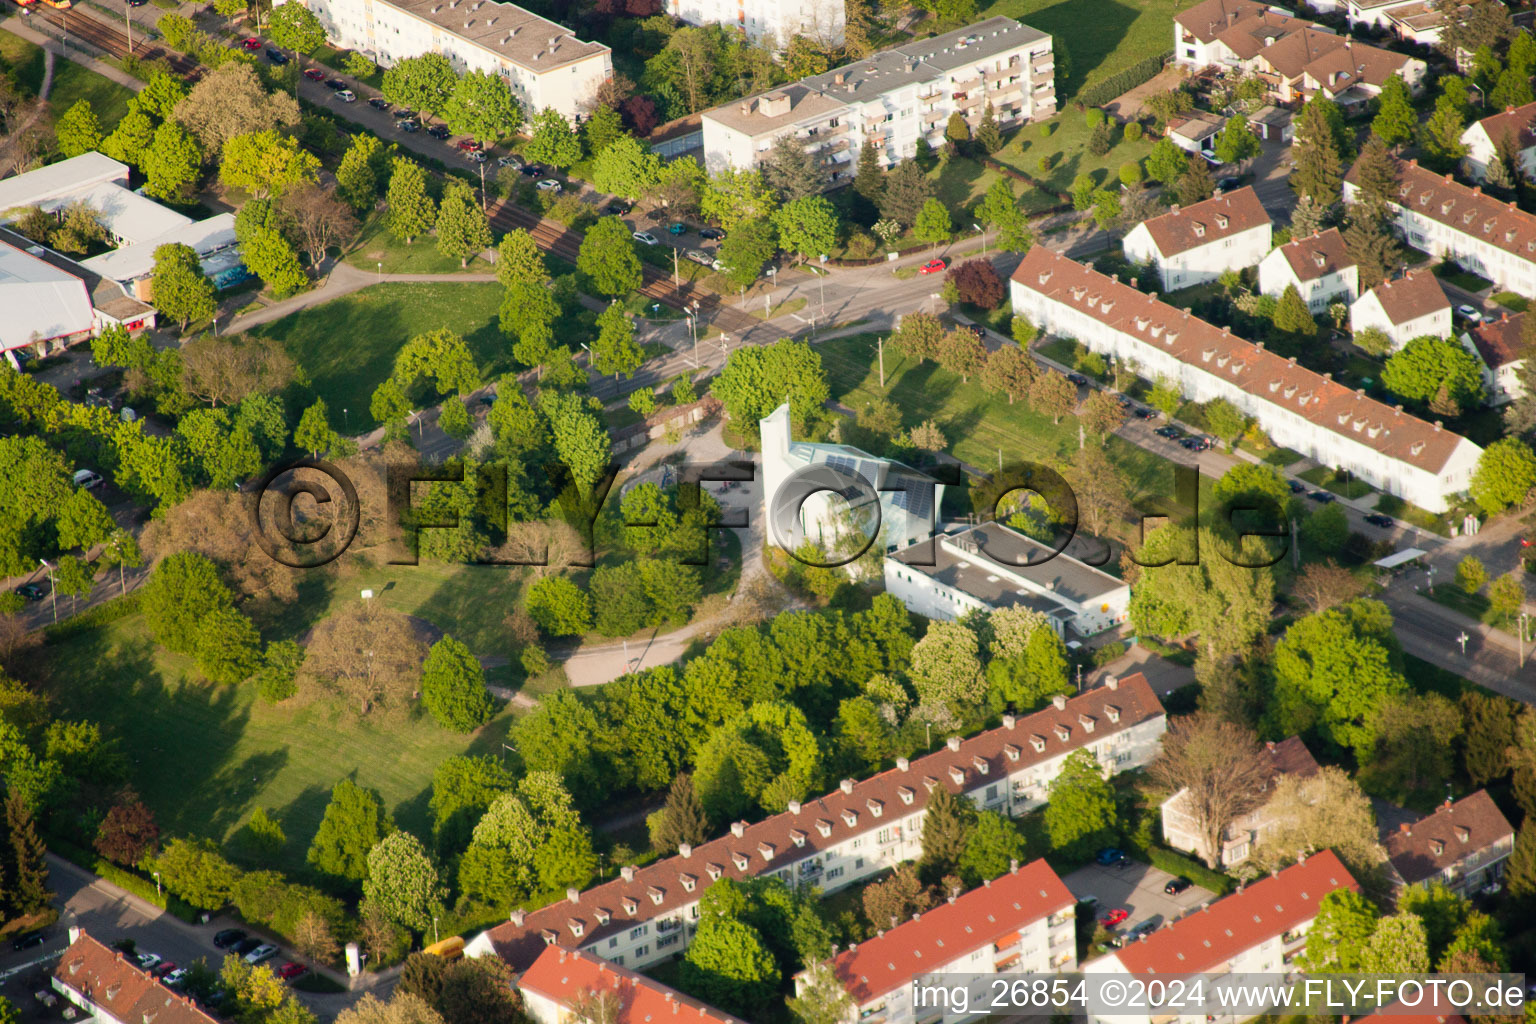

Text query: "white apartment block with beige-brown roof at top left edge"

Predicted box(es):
[273, 0, 613, 120]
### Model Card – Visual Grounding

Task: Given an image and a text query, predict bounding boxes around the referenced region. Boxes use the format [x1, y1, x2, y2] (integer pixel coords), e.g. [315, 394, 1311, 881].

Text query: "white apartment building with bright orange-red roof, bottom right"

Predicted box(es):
[1083, 851, 1359, 1024]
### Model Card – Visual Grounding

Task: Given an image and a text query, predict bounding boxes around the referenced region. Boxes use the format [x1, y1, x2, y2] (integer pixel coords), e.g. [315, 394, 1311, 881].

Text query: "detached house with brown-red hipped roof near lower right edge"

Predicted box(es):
[1382, 789, 1514, 897]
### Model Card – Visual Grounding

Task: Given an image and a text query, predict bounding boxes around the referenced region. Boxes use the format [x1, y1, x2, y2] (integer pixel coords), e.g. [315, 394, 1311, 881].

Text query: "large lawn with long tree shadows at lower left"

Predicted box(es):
[40, 604, 511, 872]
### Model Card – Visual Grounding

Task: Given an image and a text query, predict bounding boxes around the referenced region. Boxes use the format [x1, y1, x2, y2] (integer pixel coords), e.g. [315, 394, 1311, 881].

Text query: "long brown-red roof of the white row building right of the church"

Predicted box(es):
[1012, 246, 1470, 473]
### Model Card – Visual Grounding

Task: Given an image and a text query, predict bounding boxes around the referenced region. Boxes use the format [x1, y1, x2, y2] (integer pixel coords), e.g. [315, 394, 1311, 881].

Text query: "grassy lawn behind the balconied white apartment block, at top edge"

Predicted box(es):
[977, 0, 1189, 99]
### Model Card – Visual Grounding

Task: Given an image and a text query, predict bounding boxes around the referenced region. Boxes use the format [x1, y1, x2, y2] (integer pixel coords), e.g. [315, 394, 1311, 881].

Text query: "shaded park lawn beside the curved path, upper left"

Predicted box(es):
[252, 281, 513, 431]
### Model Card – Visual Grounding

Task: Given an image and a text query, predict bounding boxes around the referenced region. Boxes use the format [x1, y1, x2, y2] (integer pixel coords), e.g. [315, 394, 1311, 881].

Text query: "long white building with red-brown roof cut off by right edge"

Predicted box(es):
[1344, 160, 1536, 295]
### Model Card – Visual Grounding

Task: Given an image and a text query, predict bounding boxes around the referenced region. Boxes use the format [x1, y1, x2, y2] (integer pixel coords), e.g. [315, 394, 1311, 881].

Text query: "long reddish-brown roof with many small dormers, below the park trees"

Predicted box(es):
[487, 672, 1163, 970]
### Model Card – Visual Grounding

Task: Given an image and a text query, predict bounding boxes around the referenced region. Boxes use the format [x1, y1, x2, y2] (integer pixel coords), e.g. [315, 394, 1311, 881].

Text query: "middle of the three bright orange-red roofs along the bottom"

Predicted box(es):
[833, 860, 1075, 1006]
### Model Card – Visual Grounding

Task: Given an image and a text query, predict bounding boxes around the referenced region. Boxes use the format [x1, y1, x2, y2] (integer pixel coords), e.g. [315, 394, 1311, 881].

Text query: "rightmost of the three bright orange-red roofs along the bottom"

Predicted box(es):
[1112, 851, 1359, 975]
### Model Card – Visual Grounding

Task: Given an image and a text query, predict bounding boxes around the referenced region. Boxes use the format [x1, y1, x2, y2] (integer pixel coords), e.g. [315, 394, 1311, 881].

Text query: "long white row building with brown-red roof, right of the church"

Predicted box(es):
[1011, 246, 1482, 511]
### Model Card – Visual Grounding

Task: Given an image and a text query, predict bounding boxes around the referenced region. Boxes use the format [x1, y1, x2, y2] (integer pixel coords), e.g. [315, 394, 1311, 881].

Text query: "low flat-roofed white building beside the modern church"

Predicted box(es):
[885, 522, 1130, 639]
